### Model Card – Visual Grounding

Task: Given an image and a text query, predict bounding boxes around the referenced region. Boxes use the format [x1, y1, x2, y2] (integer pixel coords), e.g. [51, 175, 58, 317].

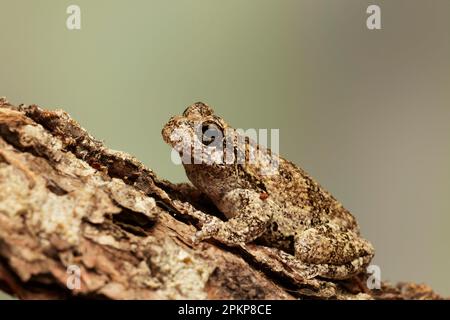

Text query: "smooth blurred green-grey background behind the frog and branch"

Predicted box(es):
[0, 0, 450, 296]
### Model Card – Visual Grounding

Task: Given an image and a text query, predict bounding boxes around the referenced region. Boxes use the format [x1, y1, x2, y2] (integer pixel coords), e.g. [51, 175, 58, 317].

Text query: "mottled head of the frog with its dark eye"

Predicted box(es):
[162, 102, 229, 168]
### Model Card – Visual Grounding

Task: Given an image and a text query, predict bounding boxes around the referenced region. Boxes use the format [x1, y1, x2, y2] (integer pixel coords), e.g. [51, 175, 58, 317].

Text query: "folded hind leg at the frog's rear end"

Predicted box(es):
[295, 223, 374, 279]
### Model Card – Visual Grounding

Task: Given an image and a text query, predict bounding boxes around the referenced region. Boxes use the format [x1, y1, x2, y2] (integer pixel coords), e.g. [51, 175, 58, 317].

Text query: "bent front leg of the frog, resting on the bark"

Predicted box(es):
[194, 189, 276, 245]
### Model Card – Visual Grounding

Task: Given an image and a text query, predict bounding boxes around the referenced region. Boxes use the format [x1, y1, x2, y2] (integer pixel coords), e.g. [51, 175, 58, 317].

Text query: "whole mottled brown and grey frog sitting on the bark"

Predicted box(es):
[162, 102, 374, 279]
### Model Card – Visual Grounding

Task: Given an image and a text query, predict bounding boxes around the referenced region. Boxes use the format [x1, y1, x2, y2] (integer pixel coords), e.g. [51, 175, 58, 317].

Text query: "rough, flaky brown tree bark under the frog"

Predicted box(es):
[0, 99, 440, 299]
